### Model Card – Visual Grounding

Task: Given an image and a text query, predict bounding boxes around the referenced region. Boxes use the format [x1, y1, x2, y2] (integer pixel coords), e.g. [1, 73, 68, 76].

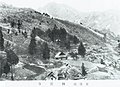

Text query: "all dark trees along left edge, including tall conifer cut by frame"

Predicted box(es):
[0, 28, 19, 80]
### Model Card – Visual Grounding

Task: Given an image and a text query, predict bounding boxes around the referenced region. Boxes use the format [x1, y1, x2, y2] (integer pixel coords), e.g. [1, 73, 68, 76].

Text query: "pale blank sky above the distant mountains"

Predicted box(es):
[0, 0, 120, 11]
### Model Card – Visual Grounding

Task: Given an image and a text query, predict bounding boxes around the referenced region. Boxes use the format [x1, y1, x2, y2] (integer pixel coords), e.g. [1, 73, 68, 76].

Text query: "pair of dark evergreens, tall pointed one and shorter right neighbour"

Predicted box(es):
[28, 28, 50, 60]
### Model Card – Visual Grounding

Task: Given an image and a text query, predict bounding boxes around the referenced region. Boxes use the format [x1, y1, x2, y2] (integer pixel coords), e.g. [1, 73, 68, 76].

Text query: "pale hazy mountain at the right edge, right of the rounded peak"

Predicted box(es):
[81, 11, 120, 35]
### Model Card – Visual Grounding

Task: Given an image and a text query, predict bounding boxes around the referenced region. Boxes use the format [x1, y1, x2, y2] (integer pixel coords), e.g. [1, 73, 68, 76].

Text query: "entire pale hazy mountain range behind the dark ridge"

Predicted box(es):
[39, 3, 120, 35]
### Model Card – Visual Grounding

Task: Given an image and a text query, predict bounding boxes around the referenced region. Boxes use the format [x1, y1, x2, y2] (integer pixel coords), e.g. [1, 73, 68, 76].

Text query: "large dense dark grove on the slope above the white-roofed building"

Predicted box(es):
[46, 25, 79, 49]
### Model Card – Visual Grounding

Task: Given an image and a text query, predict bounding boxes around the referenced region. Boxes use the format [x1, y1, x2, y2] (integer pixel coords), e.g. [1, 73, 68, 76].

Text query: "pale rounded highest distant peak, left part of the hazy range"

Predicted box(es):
[39, 2, 86, 23]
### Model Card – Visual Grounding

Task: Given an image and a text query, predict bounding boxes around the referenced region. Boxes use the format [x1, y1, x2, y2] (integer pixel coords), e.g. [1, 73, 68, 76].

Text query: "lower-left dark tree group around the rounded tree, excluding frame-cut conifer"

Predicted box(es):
[1, 38, 19, 80]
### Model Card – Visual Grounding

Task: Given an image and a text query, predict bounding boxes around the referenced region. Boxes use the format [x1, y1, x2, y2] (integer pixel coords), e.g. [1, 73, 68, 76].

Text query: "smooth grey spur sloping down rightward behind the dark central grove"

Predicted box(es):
[56, 19, 104, 44]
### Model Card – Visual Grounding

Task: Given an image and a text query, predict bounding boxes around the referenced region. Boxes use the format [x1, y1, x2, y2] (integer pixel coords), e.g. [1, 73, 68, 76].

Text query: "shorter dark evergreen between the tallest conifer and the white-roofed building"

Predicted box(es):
[42, 43, 50, 60]
